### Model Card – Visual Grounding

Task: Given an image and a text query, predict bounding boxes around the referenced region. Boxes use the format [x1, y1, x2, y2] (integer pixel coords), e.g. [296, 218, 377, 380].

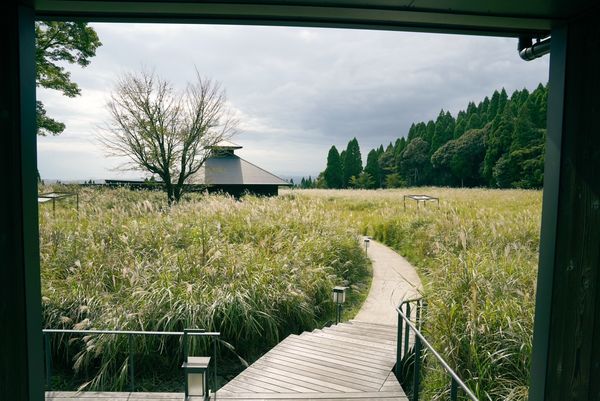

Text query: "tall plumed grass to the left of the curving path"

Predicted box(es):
[40, 189, 369, 390]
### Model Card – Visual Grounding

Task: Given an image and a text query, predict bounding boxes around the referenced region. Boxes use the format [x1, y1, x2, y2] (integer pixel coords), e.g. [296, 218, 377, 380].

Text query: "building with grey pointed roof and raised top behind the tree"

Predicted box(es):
[189, 141, 291, 197]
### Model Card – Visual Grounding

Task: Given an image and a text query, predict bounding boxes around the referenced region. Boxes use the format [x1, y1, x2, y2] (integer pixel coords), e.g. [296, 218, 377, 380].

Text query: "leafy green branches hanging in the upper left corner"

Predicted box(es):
[35, 21, 102, 135]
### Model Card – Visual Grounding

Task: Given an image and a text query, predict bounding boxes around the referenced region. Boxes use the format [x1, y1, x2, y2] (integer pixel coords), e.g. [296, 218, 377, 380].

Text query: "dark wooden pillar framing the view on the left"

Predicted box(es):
[0, 0, 43, 401]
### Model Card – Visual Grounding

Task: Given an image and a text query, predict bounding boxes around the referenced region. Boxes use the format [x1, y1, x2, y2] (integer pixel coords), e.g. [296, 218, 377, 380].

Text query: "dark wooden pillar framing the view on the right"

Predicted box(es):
[529, 8, 600, 401]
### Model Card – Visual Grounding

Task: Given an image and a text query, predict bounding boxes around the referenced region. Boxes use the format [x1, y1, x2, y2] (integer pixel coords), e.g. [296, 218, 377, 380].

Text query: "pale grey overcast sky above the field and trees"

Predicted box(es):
[38, 23, 548, 180]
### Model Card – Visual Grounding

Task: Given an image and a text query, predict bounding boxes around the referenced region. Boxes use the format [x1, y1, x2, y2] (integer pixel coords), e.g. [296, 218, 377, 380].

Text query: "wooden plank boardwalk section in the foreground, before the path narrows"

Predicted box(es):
[217, 321, 407, 401]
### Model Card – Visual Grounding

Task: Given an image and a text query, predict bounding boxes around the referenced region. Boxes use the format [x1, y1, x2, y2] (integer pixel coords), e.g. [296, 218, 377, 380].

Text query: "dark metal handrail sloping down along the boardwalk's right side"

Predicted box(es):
[396, 298, 479, 401]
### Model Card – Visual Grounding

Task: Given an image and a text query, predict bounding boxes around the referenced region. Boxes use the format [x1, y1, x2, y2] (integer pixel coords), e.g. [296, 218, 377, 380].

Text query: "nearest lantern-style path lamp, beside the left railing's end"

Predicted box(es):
[181, 329, 210, 401]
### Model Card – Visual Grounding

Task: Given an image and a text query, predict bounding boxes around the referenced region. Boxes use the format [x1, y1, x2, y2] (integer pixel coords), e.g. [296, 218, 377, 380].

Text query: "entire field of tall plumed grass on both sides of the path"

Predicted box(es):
[40, 188, 541, 400]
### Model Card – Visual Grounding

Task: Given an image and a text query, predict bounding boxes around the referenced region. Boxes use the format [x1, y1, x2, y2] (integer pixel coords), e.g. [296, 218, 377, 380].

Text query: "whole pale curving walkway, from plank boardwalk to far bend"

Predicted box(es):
[217, 241, 421, 401]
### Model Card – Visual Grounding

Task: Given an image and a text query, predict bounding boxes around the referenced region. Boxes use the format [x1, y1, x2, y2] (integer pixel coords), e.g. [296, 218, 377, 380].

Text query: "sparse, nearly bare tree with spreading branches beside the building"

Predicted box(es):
[100, 71, 238, 203]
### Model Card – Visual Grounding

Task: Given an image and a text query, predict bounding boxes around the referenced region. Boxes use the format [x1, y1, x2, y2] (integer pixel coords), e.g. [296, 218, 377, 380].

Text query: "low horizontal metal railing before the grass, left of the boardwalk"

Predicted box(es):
[42, 329, 221, 401]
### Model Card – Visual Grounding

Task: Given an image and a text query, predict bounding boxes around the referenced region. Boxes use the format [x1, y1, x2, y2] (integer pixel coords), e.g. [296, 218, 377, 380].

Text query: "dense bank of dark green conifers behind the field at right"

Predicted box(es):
[324, 84, 548, 188]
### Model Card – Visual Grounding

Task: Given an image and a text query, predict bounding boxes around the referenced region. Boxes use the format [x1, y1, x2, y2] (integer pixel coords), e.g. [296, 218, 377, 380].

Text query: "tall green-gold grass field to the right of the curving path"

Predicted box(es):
[295, 188, 541, 400]
